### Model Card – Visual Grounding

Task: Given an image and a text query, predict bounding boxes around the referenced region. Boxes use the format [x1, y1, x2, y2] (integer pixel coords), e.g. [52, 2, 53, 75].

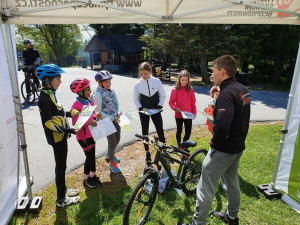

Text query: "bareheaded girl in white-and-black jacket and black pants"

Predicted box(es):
[133, 62, 166, 161]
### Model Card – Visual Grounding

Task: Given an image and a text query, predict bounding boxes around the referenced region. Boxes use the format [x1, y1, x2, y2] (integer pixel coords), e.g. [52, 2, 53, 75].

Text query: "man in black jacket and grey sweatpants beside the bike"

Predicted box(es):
[177, 55, 251, 225]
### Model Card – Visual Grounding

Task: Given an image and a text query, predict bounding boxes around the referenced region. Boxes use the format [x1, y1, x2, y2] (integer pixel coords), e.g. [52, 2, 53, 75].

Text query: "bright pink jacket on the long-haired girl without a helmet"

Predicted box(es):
[169, 87, 197, 118]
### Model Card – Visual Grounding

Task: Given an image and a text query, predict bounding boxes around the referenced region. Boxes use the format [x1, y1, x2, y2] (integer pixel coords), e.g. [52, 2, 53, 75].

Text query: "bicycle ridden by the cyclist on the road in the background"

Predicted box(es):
[21, 66, 40, 104]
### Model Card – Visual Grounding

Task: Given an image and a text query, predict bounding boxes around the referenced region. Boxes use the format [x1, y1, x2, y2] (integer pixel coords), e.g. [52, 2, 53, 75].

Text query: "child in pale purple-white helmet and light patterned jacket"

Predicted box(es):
[91, 70, 121, 173]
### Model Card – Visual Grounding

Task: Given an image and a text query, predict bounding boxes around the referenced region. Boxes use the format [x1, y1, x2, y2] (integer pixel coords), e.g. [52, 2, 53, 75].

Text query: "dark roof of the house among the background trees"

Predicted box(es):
[84, 34, 146, 53]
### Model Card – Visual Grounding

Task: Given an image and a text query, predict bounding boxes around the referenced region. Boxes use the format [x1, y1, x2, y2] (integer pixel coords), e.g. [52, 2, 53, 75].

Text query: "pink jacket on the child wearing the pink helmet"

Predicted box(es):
[72, 100, 96, 141]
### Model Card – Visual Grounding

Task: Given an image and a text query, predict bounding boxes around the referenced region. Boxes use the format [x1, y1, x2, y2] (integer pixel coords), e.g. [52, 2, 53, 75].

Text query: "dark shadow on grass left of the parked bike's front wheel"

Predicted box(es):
[76, 173, 130, 224]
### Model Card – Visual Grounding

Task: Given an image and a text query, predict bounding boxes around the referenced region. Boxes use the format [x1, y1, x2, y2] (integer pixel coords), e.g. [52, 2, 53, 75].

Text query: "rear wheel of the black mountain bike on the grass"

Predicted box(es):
[181, 149, 207, 195]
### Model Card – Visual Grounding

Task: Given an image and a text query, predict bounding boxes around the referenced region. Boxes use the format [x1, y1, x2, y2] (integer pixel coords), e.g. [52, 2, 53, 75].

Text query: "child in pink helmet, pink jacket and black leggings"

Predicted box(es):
[70, 78, 101, 188]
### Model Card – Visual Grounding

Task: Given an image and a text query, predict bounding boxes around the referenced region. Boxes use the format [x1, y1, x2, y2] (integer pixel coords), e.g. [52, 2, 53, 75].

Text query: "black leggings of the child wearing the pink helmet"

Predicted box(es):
[78, 138, 96, 175]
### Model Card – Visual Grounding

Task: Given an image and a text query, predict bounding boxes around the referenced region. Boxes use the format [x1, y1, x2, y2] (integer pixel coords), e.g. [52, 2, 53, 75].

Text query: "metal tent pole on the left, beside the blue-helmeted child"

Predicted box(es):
[4, 22, 32, 202]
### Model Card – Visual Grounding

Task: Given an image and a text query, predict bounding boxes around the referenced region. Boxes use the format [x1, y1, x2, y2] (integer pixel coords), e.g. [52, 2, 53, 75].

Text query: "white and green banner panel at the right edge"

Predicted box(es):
[275, 44, 300, 211]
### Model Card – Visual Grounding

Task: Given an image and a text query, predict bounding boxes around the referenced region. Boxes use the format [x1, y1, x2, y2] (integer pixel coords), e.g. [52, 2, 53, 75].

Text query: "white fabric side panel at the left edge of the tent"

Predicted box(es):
[0, 24, 18, 224]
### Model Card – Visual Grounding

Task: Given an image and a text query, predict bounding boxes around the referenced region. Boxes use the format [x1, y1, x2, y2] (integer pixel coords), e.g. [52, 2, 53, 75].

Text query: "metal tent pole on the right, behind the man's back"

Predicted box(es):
[271, 43, 300, 190]
